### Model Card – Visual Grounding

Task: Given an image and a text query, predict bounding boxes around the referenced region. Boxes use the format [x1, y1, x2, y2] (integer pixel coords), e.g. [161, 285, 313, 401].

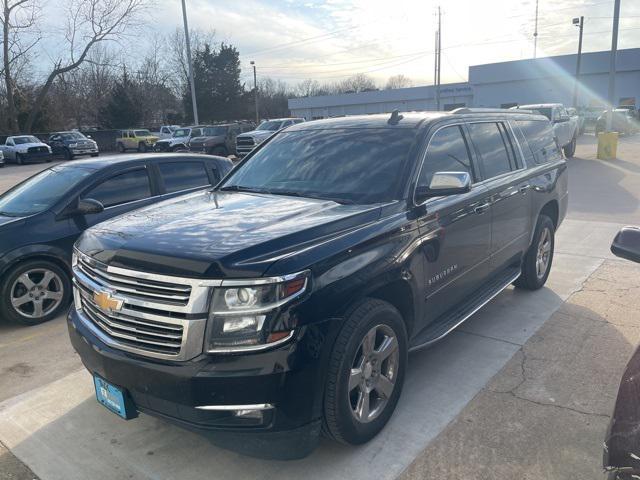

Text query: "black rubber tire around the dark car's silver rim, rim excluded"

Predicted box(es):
[0, 260, 71, 325]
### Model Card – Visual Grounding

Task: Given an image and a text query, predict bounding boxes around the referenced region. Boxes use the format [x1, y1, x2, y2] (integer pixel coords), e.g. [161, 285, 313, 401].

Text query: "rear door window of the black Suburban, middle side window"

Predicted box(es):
[469, 123, 511, 179]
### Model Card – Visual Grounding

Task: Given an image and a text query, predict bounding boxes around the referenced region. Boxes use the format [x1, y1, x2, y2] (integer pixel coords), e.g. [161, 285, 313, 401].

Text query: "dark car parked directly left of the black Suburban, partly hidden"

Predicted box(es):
[0, 154, 232, 325]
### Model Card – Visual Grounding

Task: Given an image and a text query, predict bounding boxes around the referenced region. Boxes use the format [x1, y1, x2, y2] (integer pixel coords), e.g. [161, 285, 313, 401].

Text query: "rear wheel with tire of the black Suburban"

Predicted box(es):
[513, 214, 556, 290]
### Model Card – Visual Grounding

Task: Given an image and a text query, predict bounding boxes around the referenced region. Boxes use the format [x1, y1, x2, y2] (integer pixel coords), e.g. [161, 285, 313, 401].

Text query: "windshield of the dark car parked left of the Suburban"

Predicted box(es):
[0, 166, 94, 217]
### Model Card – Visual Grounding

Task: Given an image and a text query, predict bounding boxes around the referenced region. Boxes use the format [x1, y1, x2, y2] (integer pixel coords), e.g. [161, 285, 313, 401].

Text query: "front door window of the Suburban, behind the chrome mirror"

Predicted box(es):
[418, 125, 473, 187]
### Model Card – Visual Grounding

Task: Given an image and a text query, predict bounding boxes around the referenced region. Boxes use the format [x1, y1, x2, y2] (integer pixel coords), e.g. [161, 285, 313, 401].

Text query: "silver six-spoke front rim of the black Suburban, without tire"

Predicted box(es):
[348, 325, 400, 423]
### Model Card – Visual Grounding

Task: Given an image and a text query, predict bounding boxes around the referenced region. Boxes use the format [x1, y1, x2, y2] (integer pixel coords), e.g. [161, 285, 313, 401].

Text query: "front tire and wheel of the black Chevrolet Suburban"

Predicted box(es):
[322, 299, 407, 445]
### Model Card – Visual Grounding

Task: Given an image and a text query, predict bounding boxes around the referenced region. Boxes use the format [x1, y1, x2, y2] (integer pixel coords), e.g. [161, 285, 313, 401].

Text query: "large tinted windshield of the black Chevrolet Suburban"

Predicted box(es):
[222, 128, 416, 204]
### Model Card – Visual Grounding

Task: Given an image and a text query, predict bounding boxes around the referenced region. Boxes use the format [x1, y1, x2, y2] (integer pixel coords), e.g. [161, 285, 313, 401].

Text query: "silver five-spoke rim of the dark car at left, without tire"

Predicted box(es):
[10, 268, 63, 318]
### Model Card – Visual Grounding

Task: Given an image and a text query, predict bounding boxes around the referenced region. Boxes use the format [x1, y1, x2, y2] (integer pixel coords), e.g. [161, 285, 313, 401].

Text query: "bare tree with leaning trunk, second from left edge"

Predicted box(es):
[25, 0, 147, 132]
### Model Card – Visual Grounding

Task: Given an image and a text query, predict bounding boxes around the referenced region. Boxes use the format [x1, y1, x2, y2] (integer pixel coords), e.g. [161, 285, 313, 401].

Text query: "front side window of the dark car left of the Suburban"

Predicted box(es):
[83, 169, 151, 208]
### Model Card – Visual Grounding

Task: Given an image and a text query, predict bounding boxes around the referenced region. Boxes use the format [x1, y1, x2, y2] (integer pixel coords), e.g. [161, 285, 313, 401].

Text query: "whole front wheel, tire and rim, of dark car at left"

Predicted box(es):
[0, 260, 71, 325]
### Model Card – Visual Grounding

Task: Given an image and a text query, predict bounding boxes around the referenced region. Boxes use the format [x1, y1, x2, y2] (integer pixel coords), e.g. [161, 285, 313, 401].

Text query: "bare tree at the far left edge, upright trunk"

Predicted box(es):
[0, 0, 41, 133]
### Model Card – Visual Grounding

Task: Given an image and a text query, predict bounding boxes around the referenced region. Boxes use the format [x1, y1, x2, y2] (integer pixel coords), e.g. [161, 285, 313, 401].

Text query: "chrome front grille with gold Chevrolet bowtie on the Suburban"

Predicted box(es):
[73, 250, 221, 360]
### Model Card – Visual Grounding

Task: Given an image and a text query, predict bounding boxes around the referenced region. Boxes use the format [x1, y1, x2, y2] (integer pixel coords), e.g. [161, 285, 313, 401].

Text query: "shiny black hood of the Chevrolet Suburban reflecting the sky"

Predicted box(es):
[77, 191, 380, 278]
